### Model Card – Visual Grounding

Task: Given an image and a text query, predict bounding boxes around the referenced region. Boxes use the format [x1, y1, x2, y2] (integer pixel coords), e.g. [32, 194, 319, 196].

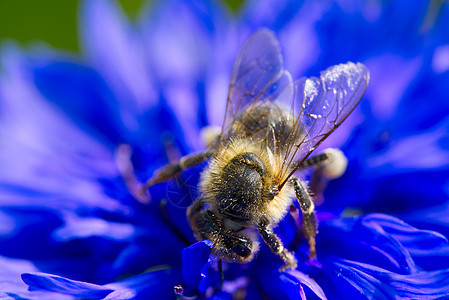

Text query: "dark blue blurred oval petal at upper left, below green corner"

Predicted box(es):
[33, 59, 128, 145]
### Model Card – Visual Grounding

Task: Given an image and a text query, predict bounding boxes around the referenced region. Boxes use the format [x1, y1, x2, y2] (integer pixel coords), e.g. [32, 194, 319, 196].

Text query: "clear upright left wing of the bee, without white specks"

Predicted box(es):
[222, 29, 293, 139]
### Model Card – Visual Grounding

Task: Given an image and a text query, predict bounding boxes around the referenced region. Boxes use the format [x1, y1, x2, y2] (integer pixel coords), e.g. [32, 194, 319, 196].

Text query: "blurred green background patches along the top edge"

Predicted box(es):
[0, 0, 243, 52]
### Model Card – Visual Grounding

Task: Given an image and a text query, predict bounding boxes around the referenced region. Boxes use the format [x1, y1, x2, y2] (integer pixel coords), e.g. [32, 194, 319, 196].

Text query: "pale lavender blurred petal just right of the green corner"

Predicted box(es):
[79, 0, 157, 110]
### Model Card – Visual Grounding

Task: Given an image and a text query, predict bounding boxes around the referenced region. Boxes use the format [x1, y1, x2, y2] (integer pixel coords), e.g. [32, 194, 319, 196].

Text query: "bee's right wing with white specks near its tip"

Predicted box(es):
[283, 62, 369, 182]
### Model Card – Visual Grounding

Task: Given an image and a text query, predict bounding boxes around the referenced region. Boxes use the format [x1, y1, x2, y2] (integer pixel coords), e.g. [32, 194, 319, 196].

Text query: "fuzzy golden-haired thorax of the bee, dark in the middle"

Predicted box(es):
[200, 132, 294, 225]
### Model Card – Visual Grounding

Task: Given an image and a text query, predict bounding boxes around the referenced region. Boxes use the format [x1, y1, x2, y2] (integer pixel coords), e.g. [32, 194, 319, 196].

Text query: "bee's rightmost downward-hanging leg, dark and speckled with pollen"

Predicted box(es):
[290, 178, 317, 258]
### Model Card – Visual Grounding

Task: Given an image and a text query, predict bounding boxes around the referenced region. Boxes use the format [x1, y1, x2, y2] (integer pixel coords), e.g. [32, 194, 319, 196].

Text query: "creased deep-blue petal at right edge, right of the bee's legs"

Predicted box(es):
[317, 214, 449, 274]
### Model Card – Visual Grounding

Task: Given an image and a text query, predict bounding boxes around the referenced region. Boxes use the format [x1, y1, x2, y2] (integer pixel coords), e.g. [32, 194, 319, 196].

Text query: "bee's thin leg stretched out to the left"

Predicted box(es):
[141, 152, 214, 194]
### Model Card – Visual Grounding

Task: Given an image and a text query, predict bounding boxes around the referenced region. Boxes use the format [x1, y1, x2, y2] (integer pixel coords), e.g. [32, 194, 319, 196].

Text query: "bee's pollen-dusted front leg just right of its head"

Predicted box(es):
[259, 220, 298, 272]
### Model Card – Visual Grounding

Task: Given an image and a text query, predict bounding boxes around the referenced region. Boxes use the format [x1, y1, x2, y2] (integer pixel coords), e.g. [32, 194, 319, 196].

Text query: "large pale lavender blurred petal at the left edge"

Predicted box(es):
[0, 47, 124, 210]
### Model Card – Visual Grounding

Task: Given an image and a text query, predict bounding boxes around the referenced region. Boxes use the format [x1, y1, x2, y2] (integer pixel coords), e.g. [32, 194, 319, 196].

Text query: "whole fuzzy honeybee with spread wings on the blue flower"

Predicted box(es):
[142, 29, 369, 271]
